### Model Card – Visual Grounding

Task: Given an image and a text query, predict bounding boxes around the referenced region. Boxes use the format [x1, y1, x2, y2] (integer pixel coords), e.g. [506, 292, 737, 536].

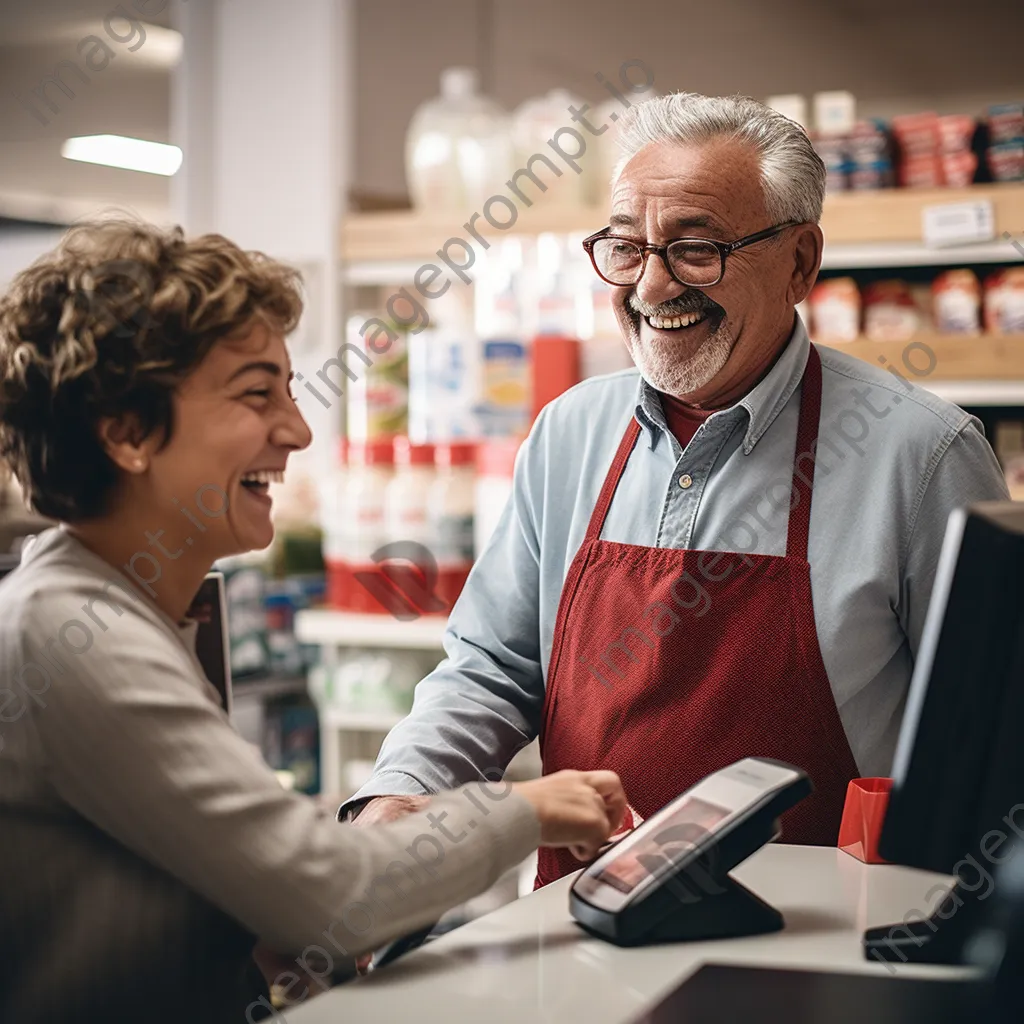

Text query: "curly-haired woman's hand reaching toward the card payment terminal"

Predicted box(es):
[512, 771, 626, 860]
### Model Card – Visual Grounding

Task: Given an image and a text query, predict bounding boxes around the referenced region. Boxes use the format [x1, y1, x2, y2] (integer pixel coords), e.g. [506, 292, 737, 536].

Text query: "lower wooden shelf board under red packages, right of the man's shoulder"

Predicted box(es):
[826, 334, 1024, 387]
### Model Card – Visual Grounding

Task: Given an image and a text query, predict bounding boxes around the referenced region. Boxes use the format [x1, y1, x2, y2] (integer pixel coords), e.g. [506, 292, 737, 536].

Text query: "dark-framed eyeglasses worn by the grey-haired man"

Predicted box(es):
[583, 220, 800, 288]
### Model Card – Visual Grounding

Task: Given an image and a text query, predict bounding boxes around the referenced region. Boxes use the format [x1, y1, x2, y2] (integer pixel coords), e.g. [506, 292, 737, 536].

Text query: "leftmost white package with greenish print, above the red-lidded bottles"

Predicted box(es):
[337, 313, 409, 440]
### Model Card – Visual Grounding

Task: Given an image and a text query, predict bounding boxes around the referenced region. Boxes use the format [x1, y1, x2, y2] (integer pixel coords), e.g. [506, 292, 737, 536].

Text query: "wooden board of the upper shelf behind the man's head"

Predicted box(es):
[341, 183, 1024, 269]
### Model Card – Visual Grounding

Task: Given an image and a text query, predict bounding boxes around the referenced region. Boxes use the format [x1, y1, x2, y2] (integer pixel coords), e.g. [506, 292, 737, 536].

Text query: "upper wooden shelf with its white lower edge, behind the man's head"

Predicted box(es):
[341, 183, 1024, 270]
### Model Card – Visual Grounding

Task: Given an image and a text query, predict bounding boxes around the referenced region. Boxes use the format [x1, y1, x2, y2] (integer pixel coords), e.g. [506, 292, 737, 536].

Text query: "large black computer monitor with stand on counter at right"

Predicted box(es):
[865, 502, 1024, 963]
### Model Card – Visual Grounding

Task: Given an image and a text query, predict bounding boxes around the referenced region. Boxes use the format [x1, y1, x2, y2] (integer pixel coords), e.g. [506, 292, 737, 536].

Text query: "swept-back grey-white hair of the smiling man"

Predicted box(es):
[612, 92, 825, 224]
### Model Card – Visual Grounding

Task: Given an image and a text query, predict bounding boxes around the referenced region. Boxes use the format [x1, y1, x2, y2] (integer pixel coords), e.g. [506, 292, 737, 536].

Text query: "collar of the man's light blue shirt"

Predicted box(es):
[635, 316, 811, 455]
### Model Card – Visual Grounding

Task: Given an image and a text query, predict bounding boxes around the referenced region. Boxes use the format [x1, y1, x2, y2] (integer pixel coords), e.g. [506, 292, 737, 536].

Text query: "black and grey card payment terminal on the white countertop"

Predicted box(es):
[569, 758, 813, 946]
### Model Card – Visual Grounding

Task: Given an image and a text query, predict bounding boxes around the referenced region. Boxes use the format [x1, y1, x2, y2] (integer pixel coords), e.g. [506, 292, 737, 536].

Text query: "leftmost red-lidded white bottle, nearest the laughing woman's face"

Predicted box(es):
[324, 440, 394, 612]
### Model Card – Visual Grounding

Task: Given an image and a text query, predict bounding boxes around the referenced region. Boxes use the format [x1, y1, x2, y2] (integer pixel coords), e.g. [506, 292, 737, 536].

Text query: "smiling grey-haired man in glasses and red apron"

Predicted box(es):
[342, 94, 1007, 883]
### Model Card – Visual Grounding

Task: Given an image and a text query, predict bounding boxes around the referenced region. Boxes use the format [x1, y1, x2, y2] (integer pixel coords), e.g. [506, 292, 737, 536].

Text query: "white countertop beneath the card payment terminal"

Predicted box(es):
[285, 844, 965, 1024]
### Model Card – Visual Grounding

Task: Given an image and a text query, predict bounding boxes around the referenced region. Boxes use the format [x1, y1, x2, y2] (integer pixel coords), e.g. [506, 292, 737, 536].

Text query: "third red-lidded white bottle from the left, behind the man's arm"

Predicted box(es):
[427, 441, 476, 606]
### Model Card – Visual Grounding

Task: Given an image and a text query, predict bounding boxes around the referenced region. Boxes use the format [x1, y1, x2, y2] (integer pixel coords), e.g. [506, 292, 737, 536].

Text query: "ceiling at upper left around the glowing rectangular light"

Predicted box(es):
[0, 0, 177, 223]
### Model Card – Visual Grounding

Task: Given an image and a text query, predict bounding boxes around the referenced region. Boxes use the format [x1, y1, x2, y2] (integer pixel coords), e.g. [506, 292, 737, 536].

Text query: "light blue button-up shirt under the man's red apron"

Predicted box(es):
[342, 319, 1007, 811]
